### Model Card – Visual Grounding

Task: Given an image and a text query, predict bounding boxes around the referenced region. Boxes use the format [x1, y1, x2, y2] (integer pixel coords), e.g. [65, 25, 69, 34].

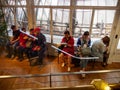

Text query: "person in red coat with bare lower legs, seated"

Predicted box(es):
[60, 30, 74, 71]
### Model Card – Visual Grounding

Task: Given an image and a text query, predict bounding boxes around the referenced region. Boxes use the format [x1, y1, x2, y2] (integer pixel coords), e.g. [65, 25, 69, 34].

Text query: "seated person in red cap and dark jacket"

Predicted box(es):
[28, 27, 46, 66]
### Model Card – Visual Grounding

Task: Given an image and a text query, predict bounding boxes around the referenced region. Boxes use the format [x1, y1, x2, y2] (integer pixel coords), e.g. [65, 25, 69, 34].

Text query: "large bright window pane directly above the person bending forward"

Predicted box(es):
[92, 10, 115, 37]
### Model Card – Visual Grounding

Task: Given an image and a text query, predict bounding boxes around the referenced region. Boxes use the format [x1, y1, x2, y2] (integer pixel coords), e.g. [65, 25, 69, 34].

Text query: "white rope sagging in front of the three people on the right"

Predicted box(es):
[52, 45, 99, 59]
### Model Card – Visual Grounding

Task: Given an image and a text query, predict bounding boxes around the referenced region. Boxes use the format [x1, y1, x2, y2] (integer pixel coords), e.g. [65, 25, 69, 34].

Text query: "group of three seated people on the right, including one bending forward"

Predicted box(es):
[59, 30, 110, 77]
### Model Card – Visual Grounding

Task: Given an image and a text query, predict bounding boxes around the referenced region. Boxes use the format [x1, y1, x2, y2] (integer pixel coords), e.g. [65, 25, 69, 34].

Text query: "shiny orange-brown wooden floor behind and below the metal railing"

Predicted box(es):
[0, 51, 120, 90]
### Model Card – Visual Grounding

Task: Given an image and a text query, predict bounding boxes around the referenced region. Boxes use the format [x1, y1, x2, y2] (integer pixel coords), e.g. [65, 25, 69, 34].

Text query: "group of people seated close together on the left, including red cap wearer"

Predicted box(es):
[6, 25, 46, 64]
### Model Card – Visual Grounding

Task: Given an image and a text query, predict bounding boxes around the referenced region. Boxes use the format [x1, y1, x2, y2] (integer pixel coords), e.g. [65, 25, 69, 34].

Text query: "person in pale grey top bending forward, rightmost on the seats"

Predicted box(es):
[91, 36, 110, 66]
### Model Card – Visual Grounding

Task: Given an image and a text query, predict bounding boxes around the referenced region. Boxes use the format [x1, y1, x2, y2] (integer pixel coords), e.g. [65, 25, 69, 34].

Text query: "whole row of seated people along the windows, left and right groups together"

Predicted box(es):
[6, 25, 110, 77]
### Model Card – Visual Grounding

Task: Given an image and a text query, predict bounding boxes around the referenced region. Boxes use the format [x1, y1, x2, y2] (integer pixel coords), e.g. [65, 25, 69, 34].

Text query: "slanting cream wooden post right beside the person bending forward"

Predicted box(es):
[108, 0, 120, 63]
